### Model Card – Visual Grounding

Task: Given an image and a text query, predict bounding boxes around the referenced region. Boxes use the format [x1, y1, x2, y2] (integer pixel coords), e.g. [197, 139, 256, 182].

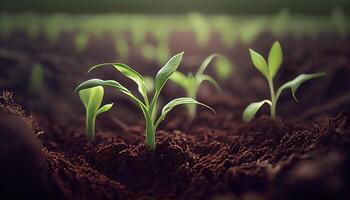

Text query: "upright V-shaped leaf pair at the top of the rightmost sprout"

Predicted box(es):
[249, 41, 283, 80]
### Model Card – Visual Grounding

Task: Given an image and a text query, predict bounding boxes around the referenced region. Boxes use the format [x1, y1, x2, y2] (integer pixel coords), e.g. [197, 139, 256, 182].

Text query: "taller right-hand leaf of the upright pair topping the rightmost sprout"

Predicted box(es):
[268, 41, 283, 80]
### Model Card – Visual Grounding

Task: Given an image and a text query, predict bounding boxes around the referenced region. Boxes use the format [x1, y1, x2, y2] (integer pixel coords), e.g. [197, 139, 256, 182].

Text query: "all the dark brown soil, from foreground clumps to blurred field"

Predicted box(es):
[0, 30, 350, 200]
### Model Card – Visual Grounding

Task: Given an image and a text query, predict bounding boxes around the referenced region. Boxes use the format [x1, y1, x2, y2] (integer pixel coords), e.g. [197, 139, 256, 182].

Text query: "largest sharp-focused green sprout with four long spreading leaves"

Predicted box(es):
[76, 53, 212, 150]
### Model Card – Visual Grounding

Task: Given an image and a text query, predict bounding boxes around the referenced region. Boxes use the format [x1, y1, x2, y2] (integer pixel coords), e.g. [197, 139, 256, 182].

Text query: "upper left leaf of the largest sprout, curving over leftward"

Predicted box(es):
[88, 63, 148, 104]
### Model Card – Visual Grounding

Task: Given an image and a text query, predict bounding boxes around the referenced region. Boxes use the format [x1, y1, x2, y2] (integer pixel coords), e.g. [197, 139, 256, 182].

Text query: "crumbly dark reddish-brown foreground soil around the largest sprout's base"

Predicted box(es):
[2, 91, 350, 199]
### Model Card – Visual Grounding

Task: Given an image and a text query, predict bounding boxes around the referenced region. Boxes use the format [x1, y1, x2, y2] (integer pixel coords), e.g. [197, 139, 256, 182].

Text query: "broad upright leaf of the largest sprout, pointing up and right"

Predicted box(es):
[155, 52, 183, 93]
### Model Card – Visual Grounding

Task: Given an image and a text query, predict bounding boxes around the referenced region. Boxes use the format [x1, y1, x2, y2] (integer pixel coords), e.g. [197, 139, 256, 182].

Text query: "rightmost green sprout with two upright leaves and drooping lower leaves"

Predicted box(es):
[243, 41, 325, 122]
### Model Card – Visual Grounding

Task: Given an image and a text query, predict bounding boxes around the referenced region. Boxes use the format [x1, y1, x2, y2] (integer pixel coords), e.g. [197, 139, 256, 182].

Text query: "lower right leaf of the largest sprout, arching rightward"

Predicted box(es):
[155, 97, 215, 128]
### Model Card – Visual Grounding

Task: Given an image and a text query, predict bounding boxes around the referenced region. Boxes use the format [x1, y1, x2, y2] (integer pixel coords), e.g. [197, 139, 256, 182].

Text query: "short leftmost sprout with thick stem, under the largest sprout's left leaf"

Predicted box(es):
[79, 86, 113, 142]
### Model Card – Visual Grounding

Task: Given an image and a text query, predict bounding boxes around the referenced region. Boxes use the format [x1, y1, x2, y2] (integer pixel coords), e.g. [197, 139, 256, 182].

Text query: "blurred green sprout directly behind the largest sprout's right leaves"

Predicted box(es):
[170, 54, 221, 119]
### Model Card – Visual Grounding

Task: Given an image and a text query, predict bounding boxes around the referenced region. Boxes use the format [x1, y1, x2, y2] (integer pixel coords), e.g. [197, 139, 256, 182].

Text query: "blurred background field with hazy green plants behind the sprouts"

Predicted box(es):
[0, 0, 350, 125]
